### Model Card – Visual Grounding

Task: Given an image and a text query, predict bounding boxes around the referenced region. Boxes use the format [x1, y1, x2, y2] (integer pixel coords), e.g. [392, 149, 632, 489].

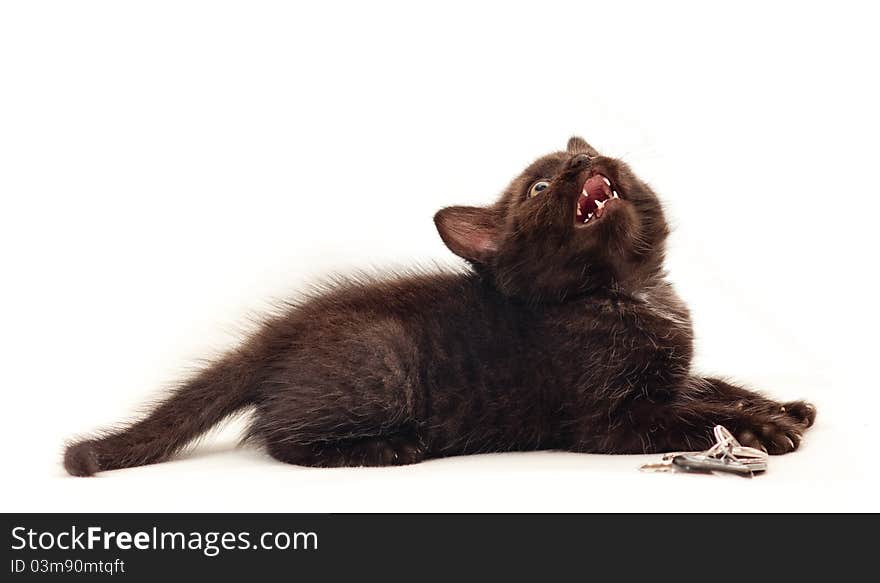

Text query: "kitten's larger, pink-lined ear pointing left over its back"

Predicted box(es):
[434, 206, 500, 263]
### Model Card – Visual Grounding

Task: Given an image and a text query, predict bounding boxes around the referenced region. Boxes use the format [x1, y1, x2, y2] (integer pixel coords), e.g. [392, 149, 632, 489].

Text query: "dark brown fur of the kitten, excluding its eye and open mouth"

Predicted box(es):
[64, 138, 815, 476]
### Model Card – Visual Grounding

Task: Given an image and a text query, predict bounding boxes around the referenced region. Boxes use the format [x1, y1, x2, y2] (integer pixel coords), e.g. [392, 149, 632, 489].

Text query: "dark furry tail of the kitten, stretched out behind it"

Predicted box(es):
[64, 350, 262, 476]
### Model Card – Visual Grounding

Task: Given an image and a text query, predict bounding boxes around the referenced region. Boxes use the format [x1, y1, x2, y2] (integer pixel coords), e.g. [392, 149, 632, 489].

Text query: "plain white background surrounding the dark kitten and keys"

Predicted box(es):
[0, 0, 880, 511]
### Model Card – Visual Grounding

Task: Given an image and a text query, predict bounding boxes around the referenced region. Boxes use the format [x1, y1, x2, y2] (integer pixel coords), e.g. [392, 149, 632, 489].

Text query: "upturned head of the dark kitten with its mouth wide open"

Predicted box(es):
[434, 137, 669, 302]
